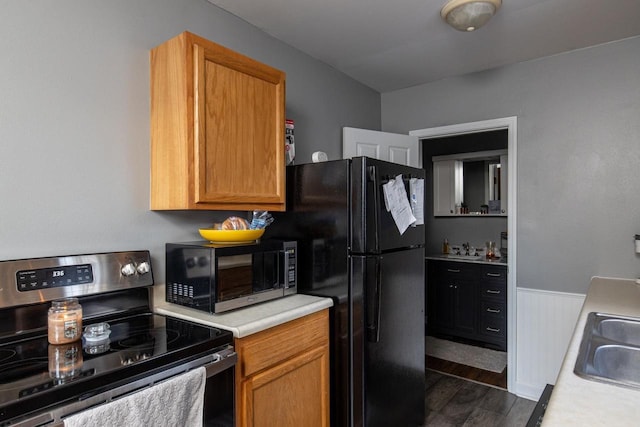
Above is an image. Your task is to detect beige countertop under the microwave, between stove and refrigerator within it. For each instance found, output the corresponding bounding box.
[153,285,333,338]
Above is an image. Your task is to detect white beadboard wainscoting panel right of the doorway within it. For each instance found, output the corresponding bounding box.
[509,288,586,400]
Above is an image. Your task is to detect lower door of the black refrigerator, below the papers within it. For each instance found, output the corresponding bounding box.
[352,248,425,427]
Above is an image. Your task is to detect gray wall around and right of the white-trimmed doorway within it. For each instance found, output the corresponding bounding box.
[382,37,640,293]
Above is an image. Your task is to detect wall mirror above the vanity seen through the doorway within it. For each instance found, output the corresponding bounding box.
[432,150,507,216]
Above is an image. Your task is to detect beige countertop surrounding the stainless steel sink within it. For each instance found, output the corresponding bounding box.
[542,277,640,427]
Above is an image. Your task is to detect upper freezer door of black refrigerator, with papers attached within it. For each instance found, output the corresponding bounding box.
[351,157,427,254]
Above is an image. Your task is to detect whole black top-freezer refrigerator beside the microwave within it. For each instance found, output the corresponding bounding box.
[265,157,425,427]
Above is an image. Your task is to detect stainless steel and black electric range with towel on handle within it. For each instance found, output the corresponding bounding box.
[0,251,237,426]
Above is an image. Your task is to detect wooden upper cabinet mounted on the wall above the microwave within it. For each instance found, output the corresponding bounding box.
[151,32,285,211]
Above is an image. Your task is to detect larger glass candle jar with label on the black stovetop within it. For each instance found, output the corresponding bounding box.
[48,298,82,344]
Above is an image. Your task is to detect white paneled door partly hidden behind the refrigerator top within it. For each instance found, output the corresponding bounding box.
[342,127,422,168]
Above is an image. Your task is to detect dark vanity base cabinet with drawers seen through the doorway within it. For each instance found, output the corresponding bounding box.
[426,260,507,351]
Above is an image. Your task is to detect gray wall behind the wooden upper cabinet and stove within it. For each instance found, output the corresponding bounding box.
[0,0,380,282]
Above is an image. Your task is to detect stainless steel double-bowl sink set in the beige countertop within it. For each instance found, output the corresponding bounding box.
[573,313,640,389]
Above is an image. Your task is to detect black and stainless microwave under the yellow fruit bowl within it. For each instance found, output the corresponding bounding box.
[166,240,298,313]
